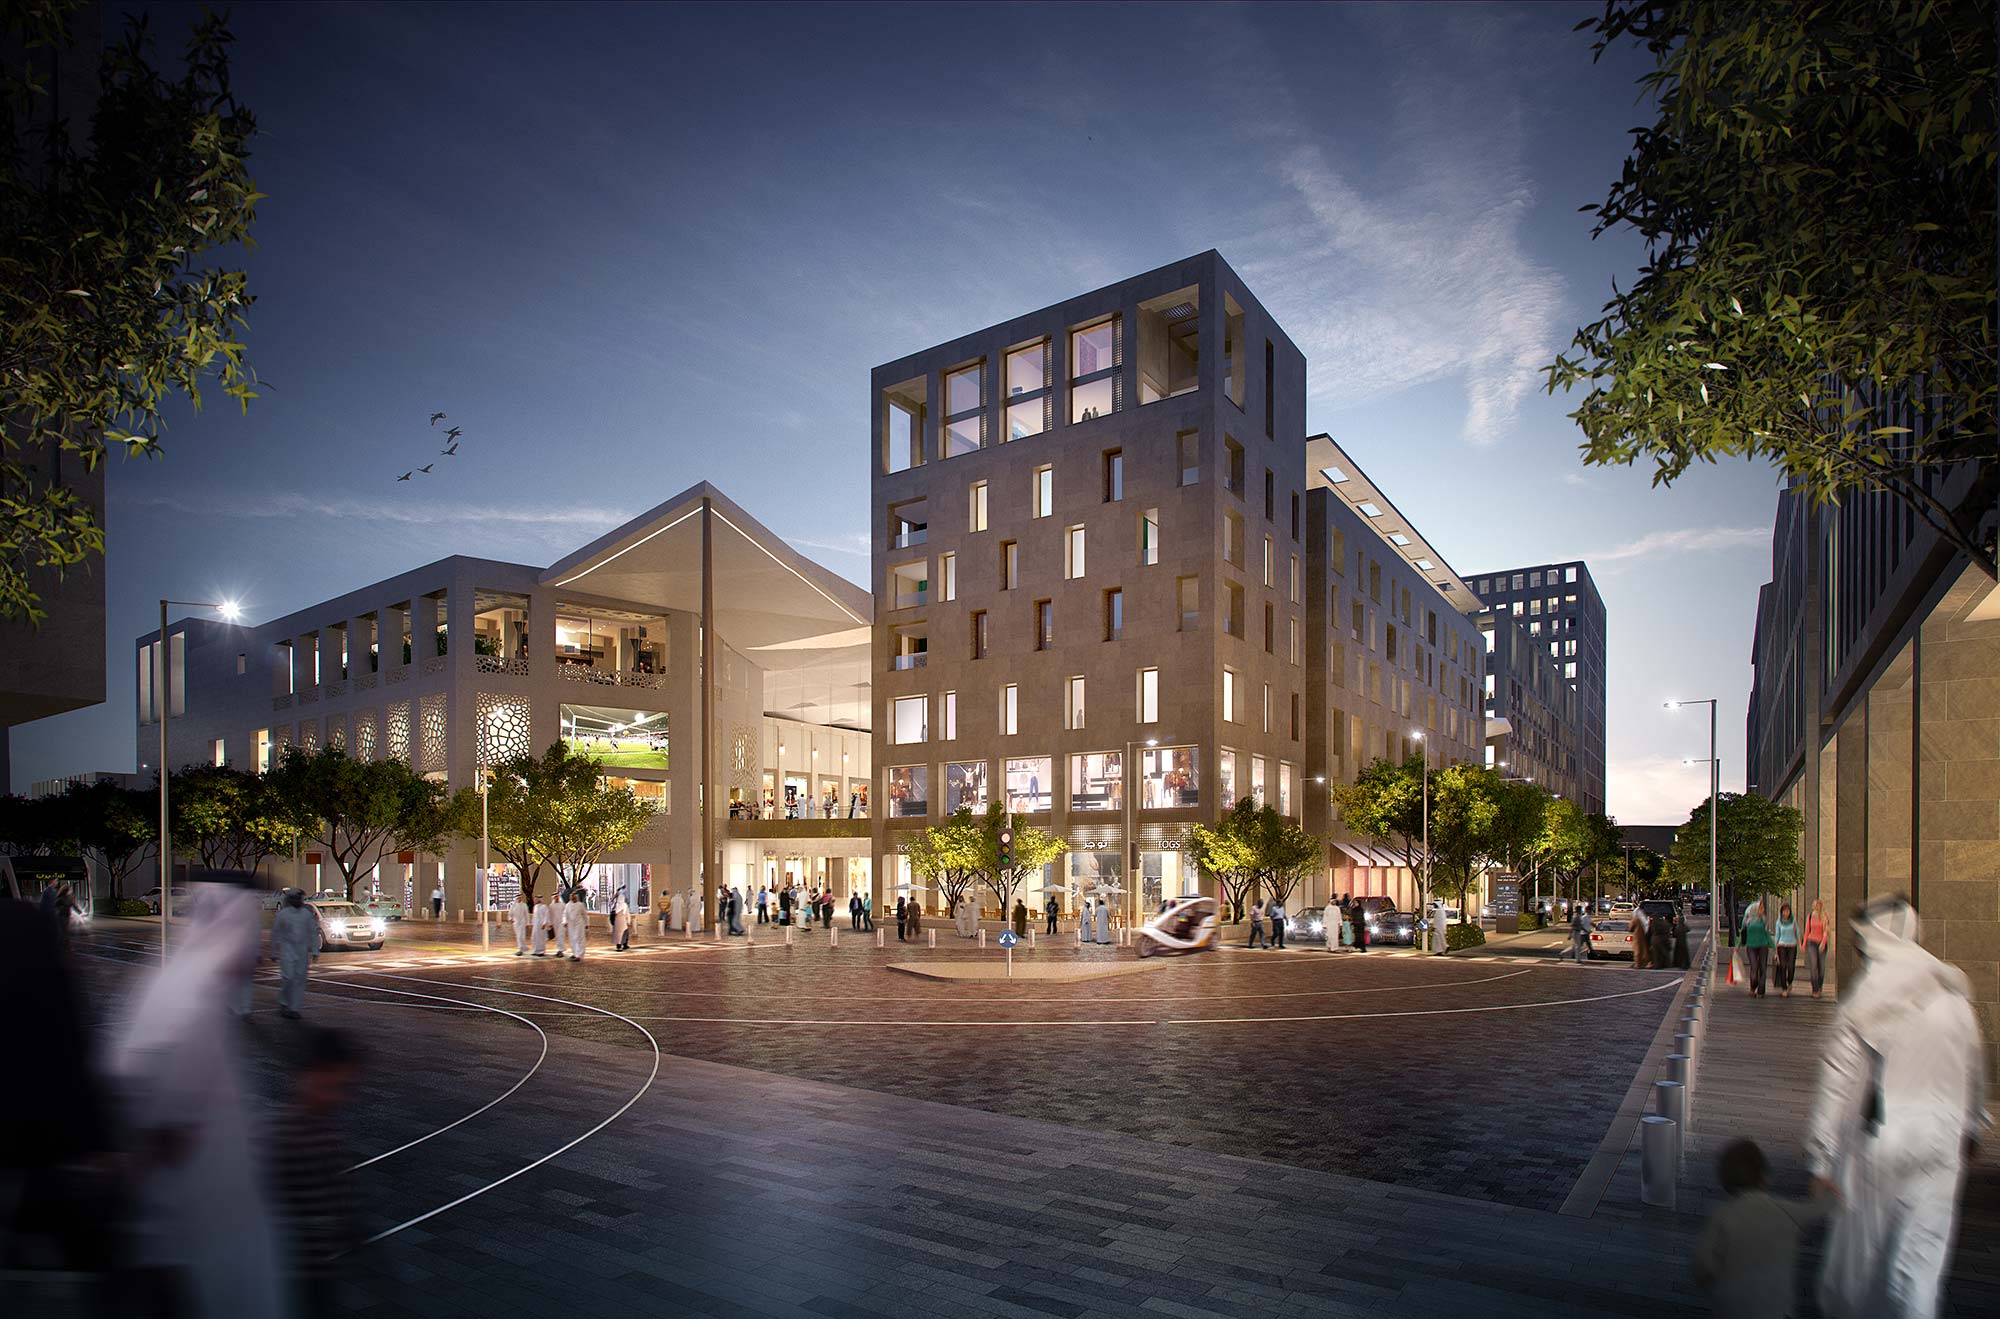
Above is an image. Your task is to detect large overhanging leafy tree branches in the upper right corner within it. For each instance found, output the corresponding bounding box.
[1548,0,2000,576]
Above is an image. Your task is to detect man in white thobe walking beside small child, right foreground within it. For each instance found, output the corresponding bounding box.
[1806,895,1986,1319]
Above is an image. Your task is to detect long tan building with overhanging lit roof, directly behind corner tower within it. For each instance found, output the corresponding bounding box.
[1302,436,1486,907]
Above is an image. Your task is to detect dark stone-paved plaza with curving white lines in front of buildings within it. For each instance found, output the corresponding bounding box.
[62,925,2000,1317]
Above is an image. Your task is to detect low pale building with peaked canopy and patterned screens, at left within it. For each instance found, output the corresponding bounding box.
[136,484,870,911]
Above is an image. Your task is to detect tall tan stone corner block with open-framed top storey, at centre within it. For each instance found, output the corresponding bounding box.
[870,252,1308,913]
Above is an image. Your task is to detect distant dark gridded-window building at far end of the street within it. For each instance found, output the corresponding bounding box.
[1468,560,1604,811]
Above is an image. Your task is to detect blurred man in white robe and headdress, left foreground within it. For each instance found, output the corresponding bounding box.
[112,883,282,1319]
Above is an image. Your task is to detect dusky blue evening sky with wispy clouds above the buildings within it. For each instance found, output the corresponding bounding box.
[14,4,1776,823]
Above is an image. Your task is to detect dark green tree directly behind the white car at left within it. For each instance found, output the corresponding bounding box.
[266,747,448,899]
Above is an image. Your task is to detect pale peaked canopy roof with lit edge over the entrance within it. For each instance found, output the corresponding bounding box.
[542,482,874,727]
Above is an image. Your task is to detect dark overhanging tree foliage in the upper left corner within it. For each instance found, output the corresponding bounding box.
[0,0,262,622]
